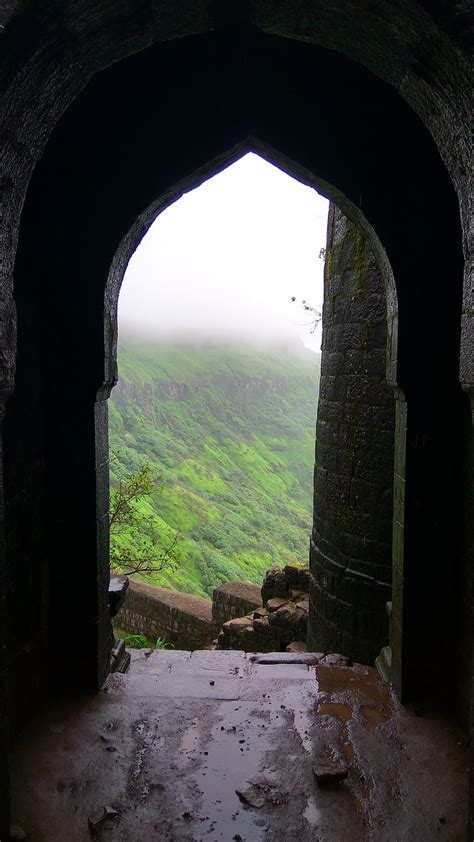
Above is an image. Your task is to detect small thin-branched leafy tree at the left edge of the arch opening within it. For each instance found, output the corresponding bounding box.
[109,453,180,576]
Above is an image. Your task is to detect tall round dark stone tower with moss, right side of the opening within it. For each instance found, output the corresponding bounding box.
[308,205,395,663]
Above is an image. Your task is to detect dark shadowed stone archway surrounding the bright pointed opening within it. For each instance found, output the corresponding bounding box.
[1,9,474,832]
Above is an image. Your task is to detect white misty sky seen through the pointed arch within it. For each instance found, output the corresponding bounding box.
[119,153,328,350]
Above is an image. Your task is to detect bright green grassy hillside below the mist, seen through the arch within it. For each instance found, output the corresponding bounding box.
[109,341,319,596]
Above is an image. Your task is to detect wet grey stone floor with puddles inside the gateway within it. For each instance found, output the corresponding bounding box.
[12,650,467,842]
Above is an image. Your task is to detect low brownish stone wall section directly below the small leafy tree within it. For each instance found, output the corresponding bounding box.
[114,580,212,649]
